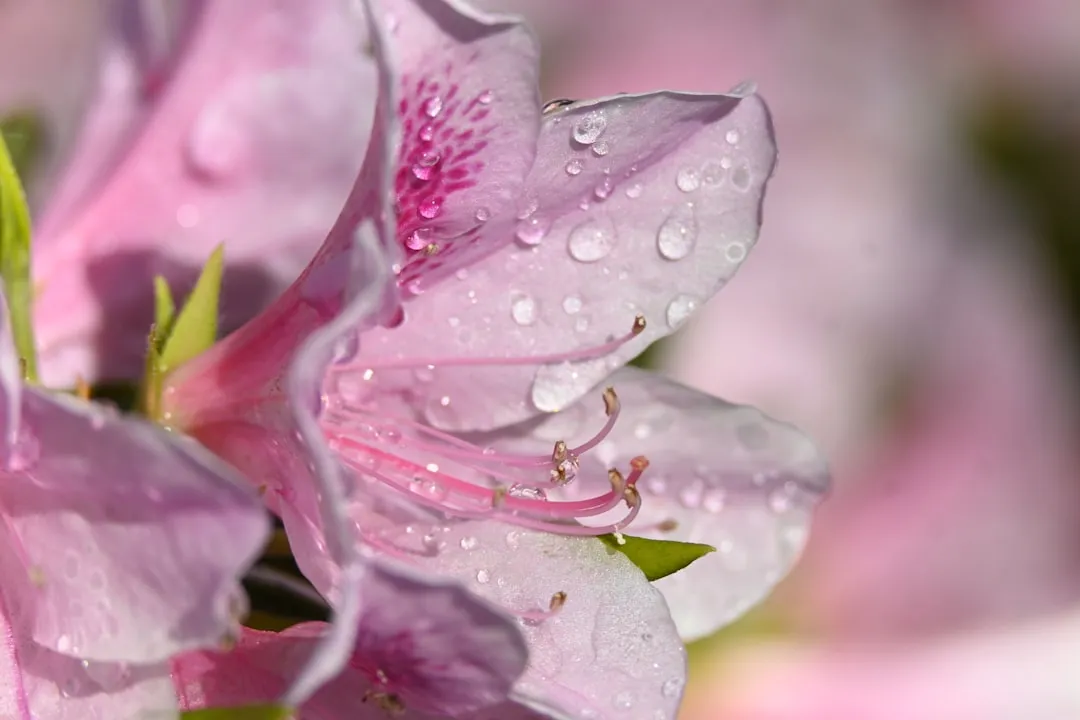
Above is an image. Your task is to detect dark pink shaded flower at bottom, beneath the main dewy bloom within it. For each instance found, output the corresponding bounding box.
[173,566,526,720]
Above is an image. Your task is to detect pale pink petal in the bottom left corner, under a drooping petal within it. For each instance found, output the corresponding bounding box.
[0,598,176,720]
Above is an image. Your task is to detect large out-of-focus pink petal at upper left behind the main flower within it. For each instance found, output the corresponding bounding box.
[35,0,375,383]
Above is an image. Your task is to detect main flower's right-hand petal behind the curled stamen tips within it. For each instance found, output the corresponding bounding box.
[480,367,828,641]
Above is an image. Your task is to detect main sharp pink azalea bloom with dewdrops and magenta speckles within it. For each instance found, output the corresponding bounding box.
[163,0,827,718]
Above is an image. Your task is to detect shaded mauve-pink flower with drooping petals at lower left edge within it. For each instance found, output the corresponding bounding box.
[0,284,268,720]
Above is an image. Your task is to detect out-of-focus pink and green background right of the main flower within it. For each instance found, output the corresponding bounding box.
[6,0,1080,720]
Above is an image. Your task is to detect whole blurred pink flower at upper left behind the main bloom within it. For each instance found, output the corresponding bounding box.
[0,0,375,384]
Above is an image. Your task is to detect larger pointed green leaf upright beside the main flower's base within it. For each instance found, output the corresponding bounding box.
[156,245,225,376]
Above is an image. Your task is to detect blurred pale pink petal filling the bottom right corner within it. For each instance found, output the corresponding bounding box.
[685,611,1080,720]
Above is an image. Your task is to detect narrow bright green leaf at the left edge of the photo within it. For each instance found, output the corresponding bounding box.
[0,131,38,382]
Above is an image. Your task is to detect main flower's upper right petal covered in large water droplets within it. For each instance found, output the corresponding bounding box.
[357,88,775,431]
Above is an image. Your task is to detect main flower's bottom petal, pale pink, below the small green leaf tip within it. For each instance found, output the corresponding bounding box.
[388,521,686,719]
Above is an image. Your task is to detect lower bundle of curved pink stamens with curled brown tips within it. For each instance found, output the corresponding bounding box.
[321,388,649,535]
